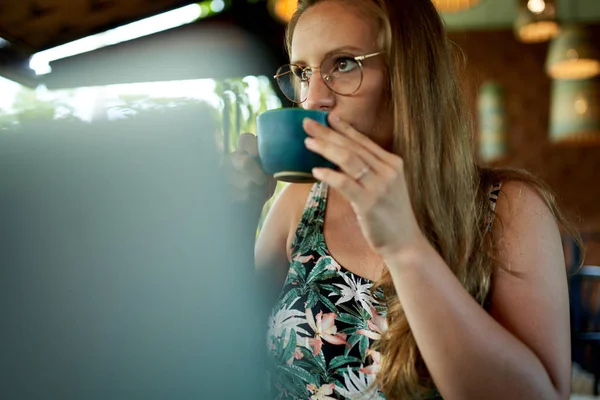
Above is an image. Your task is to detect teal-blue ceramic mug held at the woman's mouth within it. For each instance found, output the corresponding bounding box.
[256,108,336,183]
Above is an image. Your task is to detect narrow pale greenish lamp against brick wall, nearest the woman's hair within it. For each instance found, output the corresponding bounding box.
[477,81,508,162]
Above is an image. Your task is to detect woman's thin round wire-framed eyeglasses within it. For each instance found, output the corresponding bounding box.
[274,52,383,104]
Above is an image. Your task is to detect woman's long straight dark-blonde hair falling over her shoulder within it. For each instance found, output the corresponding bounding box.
[286,0,577,399]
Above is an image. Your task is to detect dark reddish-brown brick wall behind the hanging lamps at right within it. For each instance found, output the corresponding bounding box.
[450,25,600,264]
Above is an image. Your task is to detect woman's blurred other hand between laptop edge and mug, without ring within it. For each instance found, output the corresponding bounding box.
[226,133,276,213]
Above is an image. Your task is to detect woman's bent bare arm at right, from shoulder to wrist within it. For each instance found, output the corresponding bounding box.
[388,182,571,400]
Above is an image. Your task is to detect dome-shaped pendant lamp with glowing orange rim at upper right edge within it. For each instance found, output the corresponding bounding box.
[546,26,600,79]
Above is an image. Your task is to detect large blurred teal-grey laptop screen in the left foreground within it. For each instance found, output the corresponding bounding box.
[0,110,266,400]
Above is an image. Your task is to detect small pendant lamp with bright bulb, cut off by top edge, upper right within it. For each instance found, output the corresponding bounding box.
[515,0,560,43]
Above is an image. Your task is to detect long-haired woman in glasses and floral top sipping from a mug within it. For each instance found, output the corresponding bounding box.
[234,0,570,400]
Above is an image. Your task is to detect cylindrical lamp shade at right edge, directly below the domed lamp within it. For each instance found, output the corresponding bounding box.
[550,78,600,144]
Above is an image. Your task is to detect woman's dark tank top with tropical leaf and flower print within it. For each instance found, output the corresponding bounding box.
[267,183,499,400]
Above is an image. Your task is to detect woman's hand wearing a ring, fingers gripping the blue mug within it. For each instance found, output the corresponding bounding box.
[304,114,425,259]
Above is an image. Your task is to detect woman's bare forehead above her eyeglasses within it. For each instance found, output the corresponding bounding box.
[290,1,378,64]
